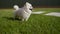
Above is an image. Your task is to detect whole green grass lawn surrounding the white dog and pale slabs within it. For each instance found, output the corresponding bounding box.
[0,8,60,34]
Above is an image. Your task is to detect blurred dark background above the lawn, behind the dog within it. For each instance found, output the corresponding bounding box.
[0,0,60,8]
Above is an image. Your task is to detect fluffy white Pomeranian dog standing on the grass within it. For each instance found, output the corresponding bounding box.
[14,2,33,21]
